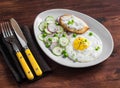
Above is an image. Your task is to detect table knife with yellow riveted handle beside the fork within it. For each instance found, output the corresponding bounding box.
[10,18,42,76]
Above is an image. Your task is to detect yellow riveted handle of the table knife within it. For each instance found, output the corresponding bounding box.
[25,48,42,76]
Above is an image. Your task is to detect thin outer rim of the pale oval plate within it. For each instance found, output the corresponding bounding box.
[33,9,114,68]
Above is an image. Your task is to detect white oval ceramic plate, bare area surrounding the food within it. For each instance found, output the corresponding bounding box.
[34,9,114,68]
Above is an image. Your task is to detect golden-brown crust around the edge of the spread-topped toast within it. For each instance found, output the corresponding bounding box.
[59,14,89,34]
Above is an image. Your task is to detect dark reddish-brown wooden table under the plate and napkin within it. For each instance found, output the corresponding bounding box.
[0,0,120,88]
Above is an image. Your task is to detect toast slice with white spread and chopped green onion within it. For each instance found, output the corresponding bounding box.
[59,14,89,34]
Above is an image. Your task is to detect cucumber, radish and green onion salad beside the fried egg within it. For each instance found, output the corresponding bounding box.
[38,16,70,58]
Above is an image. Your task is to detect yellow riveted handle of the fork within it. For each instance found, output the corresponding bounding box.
[16,52,34,80]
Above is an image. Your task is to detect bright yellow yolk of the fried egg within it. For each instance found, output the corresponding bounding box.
[73,37,90,50]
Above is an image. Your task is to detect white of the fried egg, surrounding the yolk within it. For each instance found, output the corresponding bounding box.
[66,31,103,62]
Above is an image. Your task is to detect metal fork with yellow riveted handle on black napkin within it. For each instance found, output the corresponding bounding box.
[0,22,34,80]
